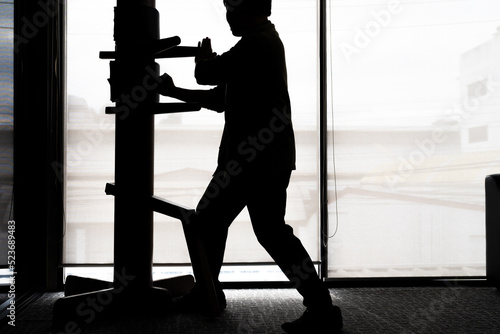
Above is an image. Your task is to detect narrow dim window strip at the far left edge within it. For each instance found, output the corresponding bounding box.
[0,1,14,284]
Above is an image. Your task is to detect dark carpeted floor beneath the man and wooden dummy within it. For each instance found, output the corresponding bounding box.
[0,286,500,334]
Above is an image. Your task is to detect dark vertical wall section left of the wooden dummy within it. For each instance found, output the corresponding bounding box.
[14,0,65,296]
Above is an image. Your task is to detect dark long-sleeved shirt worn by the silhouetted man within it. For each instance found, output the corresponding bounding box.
[195,21,295,170]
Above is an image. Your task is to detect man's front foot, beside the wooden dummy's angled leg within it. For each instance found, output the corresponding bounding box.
[173,285,227,314]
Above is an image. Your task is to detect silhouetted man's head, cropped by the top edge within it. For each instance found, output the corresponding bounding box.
[224,0,271,36]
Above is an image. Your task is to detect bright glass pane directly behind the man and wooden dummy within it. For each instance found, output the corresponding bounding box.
[64,0,319,279]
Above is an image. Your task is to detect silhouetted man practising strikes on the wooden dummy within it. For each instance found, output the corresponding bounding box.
[160,0,342,333]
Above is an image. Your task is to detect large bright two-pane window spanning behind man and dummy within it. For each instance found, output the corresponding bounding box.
[64,0,500,280]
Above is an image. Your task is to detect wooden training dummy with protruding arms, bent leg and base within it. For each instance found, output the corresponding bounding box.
[53,0,219,332]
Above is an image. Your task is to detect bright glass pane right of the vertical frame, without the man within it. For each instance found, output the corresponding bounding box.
[328,0,500,277]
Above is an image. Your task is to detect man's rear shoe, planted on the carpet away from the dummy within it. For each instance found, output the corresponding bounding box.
[281,306,343,334]
